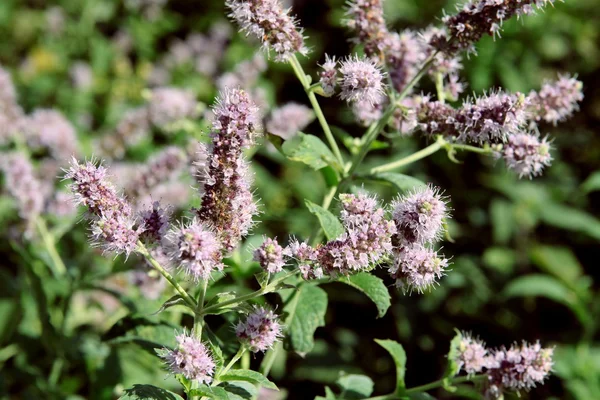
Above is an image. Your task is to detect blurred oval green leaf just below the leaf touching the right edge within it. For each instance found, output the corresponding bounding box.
[529,246,583,284]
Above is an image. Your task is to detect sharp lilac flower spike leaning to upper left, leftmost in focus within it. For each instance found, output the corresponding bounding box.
[65,159,143,255]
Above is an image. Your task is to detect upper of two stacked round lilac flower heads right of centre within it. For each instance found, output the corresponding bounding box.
[392,185,449,246]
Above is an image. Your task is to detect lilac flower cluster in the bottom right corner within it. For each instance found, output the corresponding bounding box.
[454,333,553,399]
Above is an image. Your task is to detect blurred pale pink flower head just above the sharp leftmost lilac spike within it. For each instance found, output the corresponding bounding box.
[23,109,79,160]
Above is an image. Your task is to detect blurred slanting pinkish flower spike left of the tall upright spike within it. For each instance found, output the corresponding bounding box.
[125,146,187,201]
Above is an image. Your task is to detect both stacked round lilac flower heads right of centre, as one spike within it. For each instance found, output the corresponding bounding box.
[388,186,449,292]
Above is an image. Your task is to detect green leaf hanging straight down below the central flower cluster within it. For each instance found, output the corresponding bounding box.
[283,284,327,354]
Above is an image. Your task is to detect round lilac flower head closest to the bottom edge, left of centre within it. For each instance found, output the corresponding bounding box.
[163,332,215,384]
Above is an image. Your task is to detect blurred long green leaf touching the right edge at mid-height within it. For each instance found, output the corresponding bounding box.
[540,203,600,240]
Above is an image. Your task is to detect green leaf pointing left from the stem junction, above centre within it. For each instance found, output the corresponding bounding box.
[281,132,340,170]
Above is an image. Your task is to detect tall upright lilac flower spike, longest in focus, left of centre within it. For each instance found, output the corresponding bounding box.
[197,89,261,252]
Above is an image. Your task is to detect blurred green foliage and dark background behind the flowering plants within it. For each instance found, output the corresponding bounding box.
[0,0,600,400]
